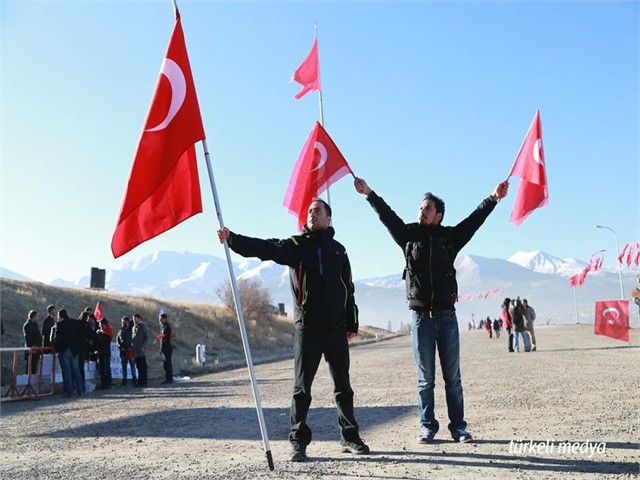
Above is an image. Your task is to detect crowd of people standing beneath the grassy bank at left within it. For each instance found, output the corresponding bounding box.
[16,305,174,397]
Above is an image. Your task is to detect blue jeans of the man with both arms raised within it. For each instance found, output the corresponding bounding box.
[411,311,467,438]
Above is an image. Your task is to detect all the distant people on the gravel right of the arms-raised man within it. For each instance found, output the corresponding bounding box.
[468,297,537,352]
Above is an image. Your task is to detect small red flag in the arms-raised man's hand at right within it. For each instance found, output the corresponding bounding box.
[509,110,549,226]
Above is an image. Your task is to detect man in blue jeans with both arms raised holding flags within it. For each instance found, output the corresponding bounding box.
[354,178,509,443]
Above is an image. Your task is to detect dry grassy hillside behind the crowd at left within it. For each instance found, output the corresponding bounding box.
[0,278,388,379]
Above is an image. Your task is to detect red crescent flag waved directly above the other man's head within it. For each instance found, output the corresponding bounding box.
[284,122,353,230]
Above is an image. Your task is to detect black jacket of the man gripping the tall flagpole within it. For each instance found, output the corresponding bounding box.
[229,226,358,333]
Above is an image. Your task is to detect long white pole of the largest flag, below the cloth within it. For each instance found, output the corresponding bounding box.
[202,140,274,470]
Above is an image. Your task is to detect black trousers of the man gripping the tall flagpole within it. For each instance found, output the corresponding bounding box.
[289,328,360,446]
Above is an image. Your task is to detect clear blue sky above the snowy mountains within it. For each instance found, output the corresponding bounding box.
[0,0,640,281]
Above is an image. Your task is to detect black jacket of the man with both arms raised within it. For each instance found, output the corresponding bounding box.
[367,191,497,310]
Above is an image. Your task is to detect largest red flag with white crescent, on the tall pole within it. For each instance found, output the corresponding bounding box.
[111,12,205,258]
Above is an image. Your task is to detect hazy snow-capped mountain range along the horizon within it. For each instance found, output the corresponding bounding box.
[0,251,638,330]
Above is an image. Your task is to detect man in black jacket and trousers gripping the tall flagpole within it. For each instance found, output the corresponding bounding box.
[218,199,369,462]
